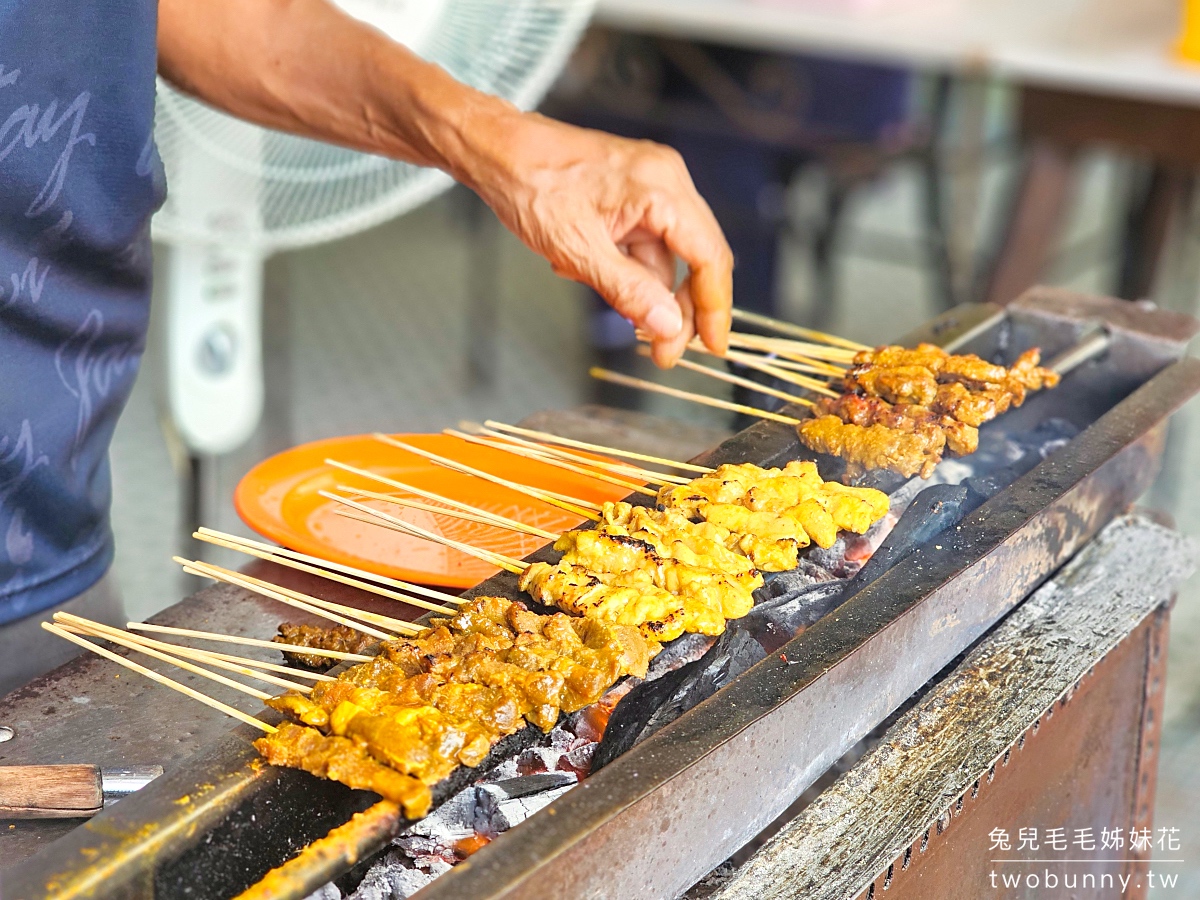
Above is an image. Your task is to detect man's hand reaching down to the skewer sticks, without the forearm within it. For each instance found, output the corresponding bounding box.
[456,110,733,366]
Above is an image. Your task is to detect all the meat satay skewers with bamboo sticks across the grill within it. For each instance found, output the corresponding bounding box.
[37,312,1057,840]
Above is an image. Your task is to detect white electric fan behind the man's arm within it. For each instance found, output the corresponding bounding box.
[154,0,594,454]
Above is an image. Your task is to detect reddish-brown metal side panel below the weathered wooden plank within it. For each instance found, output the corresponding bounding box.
[849,616,1166,900]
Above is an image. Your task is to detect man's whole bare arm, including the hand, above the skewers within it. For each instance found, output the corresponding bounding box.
[158,0,733,365]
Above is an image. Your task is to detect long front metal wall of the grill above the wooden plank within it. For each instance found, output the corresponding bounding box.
[421,360,1200,900]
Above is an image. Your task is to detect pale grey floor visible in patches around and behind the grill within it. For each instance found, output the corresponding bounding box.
[113,141,1200,896]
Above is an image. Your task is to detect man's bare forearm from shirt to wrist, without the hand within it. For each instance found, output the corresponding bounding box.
[158,0,515,182]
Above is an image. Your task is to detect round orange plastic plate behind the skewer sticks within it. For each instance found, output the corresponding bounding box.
[234,434,643,588]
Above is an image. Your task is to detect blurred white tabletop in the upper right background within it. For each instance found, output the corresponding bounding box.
[596,0,1200,106]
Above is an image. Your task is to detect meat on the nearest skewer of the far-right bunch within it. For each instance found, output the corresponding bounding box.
[797,415,946,478]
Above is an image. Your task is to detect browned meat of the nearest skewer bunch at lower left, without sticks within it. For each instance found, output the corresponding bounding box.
[256,598,660,817]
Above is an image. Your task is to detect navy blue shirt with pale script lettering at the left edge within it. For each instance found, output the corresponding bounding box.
[0,0,164,624]
